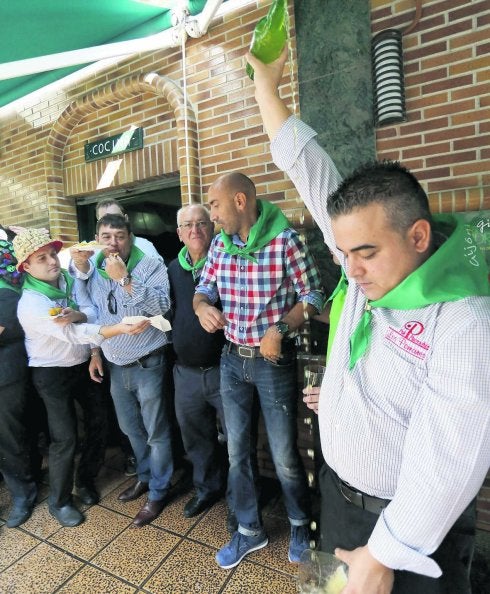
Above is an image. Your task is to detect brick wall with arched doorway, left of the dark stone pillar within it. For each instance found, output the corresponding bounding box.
[0,0,302,241]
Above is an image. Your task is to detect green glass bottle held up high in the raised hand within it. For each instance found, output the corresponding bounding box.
[246,0,288,80]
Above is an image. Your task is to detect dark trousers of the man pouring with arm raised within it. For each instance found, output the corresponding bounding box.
[320,465,476,594]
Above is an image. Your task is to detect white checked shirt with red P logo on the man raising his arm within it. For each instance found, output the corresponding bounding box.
[272,117,490,577]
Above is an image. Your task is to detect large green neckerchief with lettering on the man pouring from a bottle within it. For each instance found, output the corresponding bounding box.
[349,215,489,369]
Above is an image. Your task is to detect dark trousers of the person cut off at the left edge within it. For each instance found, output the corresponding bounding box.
[0,380,37,506]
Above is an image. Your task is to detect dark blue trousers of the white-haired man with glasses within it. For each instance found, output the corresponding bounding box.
[174,363,227,498]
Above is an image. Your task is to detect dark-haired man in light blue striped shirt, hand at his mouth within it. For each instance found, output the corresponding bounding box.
[77,214,173,527]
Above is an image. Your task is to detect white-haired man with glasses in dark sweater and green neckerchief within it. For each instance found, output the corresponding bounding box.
[168,204,232,518]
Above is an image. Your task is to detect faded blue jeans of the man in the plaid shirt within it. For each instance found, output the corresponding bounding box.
[221,346,310,535]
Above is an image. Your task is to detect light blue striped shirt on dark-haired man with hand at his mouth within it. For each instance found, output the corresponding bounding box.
[87,256,170,365]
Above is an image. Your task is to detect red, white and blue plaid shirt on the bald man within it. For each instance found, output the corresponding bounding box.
[196,229,323,346]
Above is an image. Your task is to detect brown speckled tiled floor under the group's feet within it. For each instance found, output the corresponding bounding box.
[0,450,297,594]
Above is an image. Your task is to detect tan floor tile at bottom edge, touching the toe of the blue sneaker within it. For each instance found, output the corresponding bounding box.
[144,540,229,594]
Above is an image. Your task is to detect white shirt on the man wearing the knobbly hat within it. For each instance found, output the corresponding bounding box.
[17,276,104,367]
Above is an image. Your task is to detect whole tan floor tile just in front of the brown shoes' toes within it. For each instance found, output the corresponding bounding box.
[92,525,180,586]
